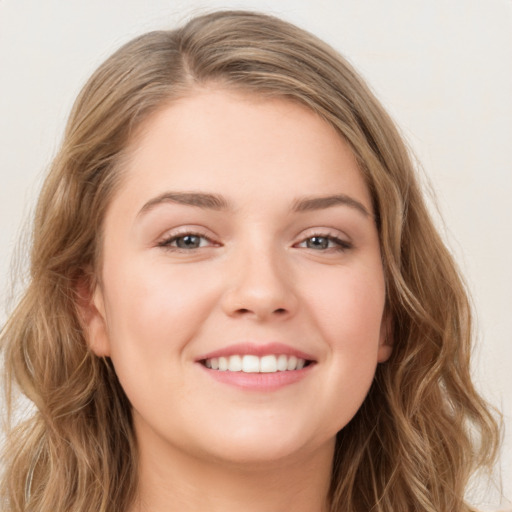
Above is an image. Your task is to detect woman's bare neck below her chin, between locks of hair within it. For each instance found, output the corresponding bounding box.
[129,428,334,512]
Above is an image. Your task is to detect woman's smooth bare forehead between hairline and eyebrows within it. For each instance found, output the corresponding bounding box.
[115,88,371,210]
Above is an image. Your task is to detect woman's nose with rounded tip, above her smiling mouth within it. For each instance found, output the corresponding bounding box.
[222,244,298,321]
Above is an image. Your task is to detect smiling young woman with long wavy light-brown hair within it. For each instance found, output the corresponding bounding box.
[2,12,497,512]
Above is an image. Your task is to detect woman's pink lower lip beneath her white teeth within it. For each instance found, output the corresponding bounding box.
[198,363,315,391]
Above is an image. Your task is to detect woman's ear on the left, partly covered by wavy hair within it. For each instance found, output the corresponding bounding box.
[75,276,110,357]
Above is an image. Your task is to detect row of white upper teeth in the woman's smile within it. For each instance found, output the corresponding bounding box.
[204,354,306,373]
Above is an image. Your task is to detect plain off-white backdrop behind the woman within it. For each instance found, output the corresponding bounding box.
[0,0,512,510]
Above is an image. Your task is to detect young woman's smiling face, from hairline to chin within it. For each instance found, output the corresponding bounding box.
[89,89,391,468]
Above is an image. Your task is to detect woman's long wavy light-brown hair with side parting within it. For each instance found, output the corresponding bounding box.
[1,11,498,512]
